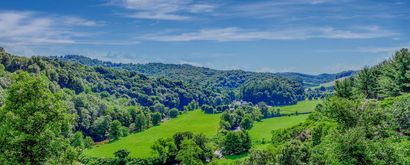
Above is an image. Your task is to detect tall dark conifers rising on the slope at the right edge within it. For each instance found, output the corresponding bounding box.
[336,48,410,99]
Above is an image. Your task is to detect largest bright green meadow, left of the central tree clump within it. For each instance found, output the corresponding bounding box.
[85,110,223,157]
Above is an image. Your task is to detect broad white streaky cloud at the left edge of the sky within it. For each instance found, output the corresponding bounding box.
[0,11,139,47]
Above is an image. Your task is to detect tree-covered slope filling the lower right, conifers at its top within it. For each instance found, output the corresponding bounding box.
[239,49,410,165]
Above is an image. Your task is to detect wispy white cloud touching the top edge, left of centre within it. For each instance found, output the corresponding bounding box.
[109,0,216,21]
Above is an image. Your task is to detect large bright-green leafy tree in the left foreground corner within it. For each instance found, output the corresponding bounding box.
[0,72,76,164]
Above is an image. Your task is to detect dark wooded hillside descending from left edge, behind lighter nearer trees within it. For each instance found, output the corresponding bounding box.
[0,53,225,109]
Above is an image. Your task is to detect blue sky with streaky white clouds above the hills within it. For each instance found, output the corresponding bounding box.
[0,0,410,74]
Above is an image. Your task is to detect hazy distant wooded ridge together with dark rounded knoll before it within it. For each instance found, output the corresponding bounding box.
[57,55,356,104]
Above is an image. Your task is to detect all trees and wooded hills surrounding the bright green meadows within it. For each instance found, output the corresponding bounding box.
[0,49,410,164]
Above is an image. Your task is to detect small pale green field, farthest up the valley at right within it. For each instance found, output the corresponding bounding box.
[278,100,322,114]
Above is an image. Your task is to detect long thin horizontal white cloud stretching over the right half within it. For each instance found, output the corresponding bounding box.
[139,26,397,42]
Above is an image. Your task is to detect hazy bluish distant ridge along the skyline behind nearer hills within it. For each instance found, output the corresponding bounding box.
[55,55,356,89]
